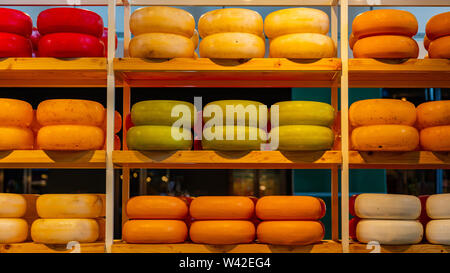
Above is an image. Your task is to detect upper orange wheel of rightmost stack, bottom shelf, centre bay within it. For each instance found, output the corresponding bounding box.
[256,196,326,220]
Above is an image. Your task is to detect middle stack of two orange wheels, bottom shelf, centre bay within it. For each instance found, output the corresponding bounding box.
[189,196,255,245]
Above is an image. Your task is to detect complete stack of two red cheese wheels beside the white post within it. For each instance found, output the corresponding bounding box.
[37,8,105,58]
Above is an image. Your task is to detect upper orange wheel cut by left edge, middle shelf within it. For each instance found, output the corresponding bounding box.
[0,98,33,127]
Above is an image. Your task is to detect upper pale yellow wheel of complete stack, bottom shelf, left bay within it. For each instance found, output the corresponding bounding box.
[36,194,103,218]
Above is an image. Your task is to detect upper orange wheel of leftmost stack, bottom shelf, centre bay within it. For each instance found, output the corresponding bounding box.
[127,195,188,219]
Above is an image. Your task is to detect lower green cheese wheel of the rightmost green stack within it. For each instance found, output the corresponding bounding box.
[270,125,334,151]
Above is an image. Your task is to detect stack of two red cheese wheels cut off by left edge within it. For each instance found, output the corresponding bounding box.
[0,8,33,58]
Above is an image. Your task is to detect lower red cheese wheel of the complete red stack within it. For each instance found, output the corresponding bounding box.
[38,32,105,58]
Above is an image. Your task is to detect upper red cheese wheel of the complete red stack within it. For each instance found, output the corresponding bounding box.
[37,8,103,38]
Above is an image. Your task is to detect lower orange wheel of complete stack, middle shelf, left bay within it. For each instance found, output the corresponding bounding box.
[36,125,104,151]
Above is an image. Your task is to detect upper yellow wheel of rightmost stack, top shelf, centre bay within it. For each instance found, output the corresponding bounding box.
[264,8,330,39]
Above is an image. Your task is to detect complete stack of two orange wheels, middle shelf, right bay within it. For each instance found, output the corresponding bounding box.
[349,99,419,151]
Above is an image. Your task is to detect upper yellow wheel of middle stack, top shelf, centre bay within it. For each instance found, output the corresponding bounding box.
[198,8,263,38]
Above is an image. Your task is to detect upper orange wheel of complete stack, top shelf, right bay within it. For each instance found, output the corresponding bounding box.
[352,9,418,39]
